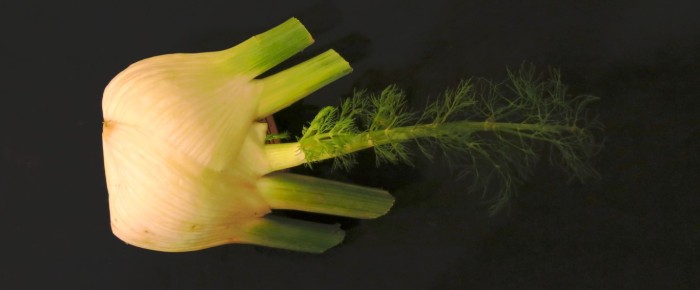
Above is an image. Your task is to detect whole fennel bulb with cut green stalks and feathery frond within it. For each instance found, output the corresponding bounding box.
[102,18,597,253]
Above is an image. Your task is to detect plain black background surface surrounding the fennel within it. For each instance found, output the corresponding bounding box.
[0,0,700,289]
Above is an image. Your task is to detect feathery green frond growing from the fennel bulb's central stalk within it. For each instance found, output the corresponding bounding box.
[299,66,601,212]
